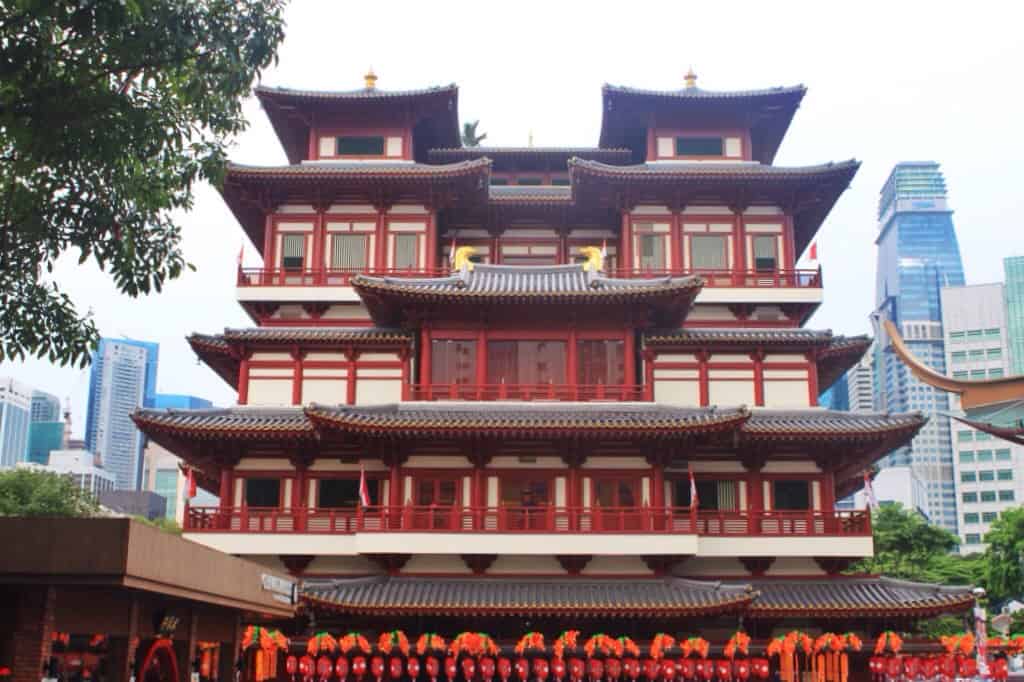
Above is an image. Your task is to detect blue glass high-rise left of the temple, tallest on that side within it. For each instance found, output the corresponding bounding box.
[85,339,160,489]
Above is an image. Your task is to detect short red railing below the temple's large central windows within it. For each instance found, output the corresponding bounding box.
[410,384,653,402]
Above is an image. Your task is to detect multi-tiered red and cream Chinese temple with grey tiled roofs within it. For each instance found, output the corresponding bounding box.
[134,72,973,682]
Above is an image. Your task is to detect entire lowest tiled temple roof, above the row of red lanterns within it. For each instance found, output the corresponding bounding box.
[301,576,974,619]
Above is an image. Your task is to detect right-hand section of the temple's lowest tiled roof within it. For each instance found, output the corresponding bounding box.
[748,577,974,617]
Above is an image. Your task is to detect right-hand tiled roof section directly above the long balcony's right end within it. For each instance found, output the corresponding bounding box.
[740,408,928,441]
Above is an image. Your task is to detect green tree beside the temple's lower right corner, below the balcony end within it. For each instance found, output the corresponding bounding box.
[850,504,984,585]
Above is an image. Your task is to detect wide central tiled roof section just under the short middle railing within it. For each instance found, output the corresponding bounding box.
[307,402,748,438]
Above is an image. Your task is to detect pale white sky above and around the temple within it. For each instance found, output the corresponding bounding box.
[0,0,1024,434]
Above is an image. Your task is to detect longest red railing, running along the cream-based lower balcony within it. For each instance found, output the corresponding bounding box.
[184,505,871,538]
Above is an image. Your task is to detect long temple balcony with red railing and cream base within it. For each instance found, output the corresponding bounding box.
[184,505,872,557]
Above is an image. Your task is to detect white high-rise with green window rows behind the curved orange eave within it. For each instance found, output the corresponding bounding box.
[942,284,1024,553]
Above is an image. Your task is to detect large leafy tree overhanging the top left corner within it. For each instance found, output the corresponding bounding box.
[0,0,284,365]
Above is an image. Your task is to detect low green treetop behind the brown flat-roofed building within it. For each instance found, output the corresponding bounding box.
[0,469,99,516]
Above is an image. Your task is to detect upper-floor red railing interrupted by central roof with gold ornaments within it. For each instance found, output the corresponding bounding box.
[238,267,821,289]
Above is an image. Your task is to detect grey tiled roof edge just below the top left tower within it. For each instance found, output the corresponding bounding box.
[227,159,490,179]
